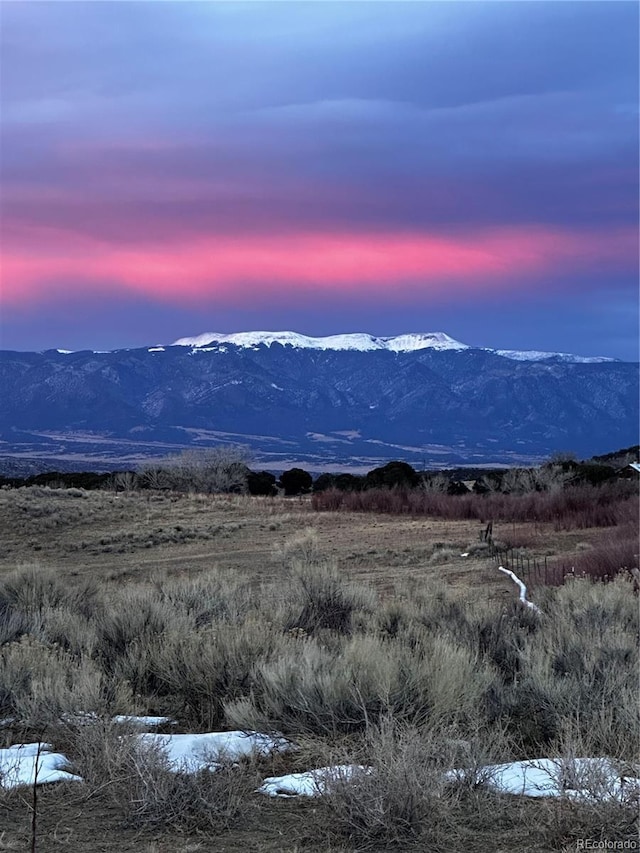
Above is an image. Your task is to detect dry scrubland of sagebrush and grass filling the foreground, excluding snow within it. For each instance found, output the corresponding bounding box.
[0,487,640,853]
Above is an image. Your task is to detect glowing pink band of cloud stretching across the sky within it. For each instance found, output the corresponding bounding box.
[0,227,637,305]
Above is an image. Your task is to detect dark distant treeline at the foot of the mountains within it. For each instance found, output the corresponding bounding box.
[0,445,640,496]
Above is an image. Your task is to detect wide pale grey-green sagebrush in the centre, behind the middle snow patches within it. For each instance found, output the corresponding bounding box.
[225,631,494,734]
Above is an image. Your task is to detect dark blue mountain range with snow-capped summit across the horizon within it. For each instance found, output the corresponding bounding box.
[0,332,639,470]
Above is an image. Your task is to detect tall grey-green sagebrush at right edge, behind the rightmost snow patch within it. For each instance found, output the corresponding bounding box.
[498,577,639,760]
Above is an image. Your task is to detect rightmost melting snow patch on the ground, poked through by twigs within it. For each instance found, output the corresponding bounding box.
[447,758,640,800]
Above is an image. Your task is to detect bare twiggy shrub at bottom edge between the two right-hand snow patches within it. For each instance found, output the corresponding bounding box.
[323,717,516,851]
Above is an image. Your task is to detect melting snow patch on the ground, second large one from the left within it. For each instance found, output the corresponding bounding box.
[137,732,294,773]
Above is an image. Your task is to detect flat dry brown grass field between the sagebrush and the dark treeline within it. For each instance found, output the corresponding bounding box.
[0,487,620,599]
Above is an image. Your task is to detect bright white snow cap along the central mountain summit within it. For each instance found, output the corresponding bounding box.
[173,332,469,352]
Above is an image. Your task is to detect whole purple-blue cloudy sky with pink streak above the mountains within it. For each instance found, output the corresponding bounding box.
[0,0,640,360]
